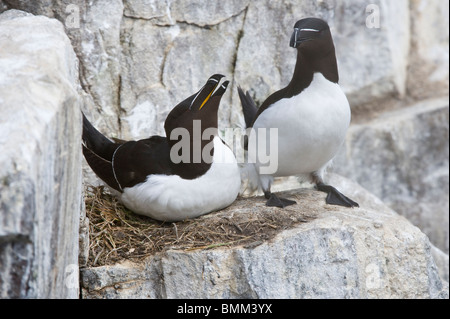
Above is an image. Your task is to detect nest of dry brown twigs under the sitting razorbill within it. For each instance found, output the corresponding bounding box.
[85,187,312,267]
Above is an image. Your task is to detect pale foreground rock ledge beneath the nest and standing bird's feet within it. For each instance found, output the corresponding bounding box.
[81,182,448,298]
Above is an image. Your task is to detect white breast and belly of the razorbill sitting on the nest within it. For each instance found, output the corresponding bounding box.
[120,137,241,221]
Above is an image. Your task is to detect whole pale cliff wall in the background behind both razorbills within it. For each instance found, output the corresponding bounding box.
[0,0,449,295]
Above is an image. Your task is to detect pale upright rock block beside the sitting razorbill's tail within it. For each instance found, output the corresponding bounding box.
[0,10,82,298]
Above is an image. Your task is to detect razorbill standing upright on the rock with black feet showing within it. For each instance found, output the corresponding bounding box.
[238,18,359,208]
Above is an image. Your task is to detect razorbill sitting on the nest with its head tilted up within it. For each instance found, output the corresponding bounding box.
[83,74,241,221]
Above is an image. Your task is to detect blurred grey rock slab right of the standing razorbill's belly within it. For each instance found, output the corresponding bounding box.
[333,97,449,253]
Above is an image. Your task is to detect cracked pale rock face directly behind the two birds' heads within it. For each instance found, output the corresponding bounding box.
[5,0,410,138]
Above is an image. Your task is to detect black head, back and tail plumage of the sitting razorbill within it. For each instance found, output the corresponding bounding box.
[82,75,228,191]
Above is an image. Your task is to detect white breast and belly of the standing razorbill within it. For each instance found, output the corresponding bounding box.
[249,73,350,177]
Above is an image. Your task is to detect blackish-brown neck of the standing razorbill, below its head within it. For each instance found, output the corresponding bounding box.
[286,47,339,96]
